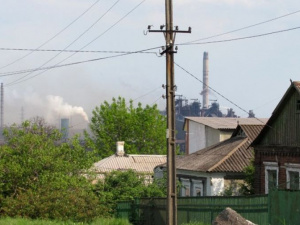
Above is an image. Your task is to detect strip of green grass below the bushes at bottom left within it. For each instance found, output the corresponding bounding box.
[0,218,131,225]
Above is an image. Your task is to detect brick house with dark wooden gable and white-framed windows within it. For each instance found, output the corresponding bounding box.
[252,81,300,194]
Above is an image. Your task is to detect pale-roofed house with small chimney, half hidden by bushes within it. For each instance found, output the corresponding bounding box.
[93,141,167,181]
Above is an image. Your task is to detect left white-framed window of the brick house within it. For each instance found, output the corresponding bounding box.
[263,162,278,194]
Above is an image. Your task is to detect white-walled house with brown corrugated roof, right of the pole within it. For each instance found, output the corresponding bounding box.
[154,125,263,196]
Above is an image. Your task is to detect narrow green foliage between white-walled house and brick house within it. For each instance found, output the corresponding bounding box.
[240,160,255,195]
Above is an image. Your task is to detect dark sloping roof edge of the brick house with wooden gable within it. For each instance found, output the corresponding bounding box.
[251,81,300,146]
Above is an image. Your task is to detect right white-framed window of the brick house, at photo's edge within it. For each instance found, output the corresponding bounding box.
[285,163,300,190]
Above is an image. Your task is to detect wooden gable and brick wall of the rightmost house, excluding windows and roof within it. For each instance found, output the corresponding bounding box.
[254,90,300,194]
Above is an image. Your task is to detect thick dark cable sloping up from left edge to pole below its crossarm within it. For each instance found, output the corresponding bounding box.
[0,47,161,78]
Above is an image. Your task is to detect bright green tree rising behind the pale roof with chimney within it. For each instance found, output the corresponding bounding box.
[90,97,166,157]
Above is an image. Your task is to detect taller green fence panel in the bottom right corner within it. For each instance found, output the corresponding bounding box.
[269,190,300,225]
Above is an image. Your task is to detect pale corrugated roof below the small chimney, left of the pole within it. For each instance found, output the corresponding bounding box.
[94,155,167,173]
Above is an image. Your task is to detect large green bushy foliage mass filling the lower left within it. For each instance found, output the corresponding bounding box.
[0,121,103,221]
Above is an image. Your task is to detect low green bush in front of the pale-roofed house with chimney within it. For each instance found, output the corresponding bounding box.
[95,170,166,214]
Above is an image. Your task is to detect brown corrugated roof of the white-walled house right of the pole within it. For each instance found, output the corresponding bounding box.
[163,125,263,173]
